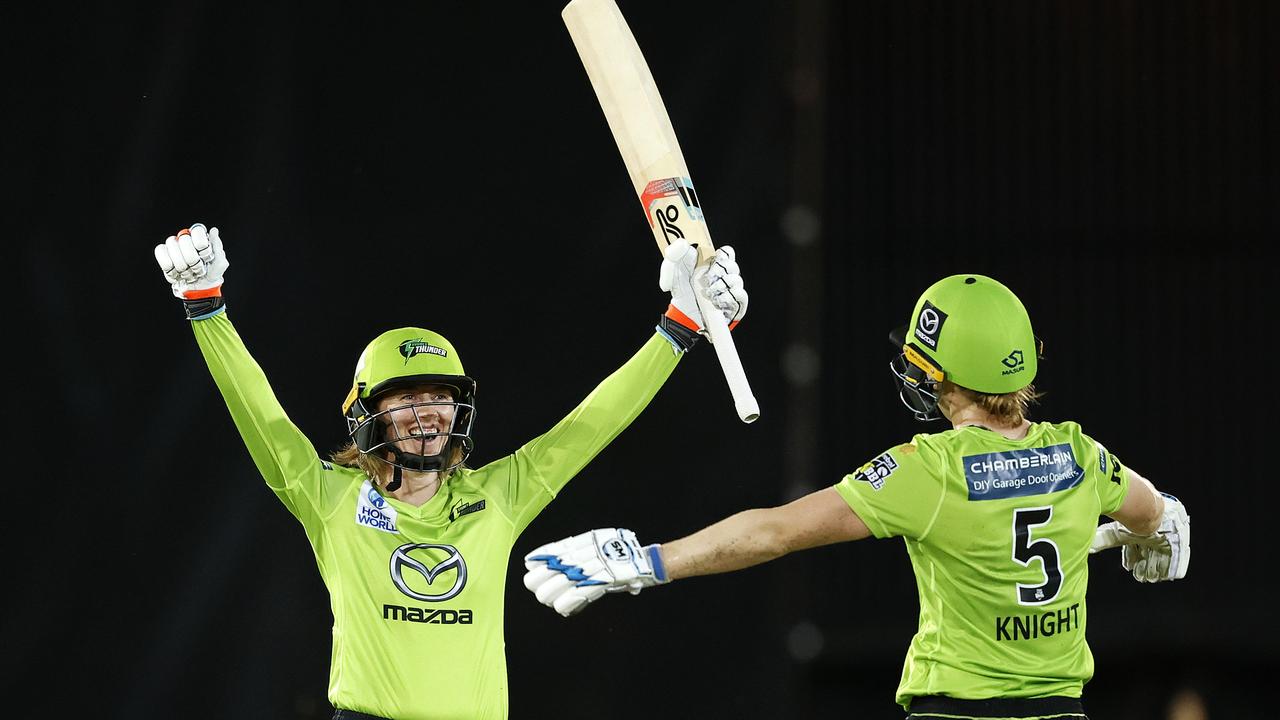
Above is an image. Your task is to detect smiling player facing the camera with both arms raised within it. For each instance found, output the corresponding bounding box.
[155,223,748,720]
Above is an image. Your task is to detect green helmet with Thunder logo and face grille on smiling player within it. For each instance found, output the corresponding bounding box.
[342,328,476,479]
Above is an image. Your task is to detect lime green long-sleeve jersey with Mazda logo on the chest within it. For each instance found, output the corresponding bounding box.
[192,313,680,720]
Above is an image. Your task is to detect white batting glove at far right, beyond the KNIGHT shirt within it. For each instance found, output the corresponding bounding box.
[1089,492,1192,583]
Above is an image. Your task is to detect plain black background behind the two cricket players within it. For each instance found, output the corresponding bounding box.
[0,0,1280,720]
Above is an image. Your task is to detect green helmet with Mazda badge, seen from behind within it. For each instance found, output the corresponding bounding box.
[890,274,1041,420]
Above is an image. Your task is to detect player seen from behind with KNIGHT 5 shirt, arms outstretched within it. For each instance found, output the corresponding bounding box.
[525,274,1190,720]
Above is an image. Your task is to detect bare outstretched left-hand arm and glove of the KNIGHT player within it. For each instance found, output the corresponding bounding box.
[525,488,872,618]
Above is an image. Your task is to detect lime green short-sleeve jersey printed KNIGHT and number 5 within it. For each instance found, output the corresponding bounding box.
[836,423,1129,707]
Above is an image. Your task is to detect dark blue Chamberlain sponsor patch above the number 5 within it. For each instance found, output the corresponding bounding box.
[963,443,1084,500]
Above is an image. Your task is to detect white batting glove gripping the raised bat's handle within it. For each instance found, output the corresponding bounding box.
[658,240,748,334]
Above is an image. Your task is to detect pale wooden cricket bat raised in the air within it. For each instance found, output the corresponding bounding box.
[561,0,760,423]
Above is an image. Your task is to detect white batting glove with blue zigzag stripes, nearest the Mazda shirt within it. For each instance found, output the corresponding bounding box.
[525,528,667,618]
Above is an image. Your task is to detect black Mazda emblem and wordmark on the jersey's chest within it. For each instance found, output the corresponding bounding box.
[383,543,472,625]
